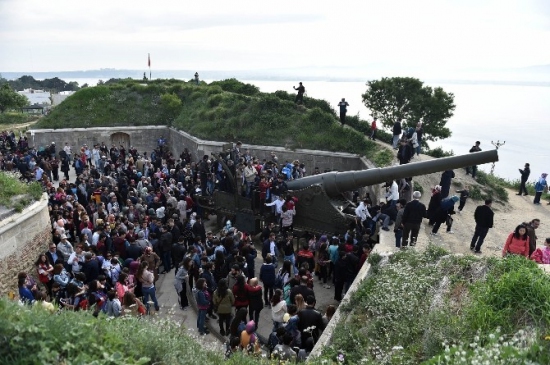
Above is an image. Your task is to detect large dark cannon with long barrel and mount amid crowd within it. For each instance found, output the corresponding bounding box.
[203,150,498,233]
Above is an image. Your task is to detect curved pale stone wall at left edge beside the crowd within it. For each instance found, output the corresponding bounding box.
[0,194,51,296]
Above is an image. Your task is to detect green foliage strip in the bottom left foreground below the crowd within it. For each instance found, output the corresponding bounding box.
[0,299,266,365]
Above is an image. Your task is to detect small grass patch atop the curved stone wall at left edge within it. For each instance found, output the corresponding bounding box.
[0,171,42,212]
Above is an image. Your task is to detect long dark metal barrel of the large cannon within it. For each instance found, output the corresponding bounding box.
[287,150,498,197]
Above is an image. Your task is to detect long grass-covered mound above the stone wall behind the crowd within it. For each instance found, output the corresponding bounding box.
[34,79,390,165]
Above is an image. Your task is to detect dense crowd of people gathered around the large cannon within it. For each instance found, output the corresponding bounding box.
[0,124,550,360]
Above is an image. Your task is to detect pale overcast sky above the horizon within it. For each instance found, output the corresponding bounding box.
[0,0,550,74]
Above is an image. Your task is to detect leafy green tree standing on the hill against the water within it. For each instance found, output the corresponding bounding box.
[362,77,455,141]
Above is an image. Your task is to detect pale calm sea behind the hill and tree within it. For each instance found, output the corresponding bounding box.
[66,79,550,181]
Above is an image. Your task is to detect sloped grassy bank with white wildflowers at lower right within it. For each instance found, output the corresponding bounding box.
[316,246,550,364]
